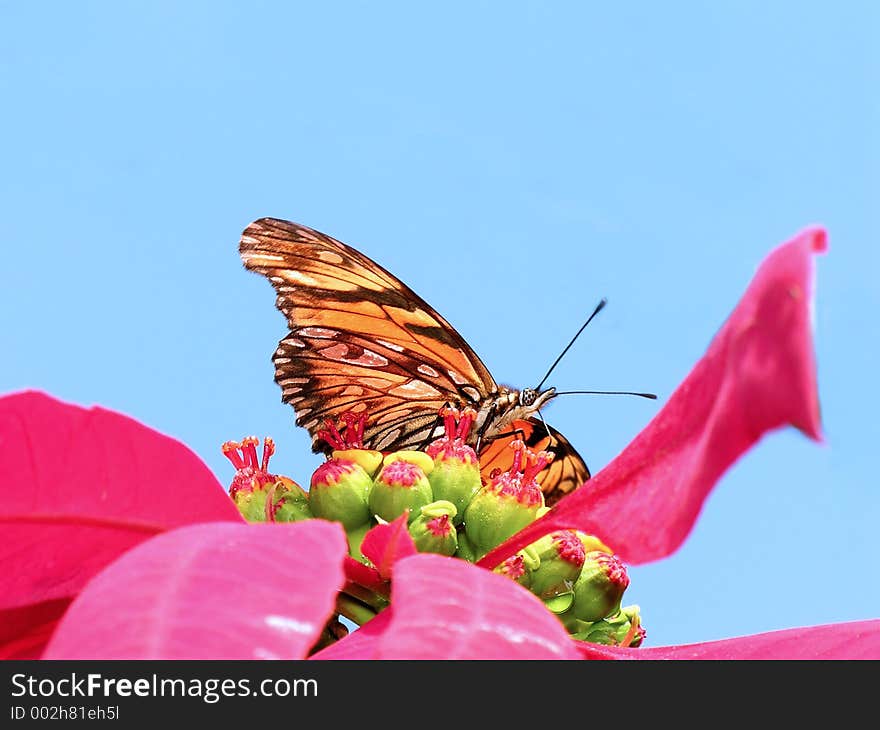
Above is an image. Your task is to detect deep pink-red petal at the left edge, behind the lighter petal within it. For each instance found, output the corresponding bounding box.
[0,392,241,610]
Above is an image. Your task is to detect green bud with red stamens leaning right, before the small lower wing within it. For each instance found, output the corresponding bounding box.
[464,441,551,555]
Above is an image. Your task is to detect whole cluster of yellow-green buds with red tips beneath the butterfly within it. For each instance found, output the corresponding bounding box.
[225,409,645,646]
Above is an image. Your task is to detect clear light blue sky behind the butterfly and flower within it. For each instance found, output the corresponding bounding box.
[0,2,880,645]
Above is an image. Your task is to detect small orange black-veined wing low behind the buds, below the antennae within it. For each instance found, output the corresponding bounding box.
[480,418,590,506]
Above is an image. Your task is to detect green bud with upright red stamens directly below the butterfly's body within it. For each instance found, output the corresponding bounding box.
[425,408,483,525]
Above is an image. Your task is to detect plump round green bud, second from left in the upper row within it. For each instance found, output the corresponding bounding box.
[309,459,373,530]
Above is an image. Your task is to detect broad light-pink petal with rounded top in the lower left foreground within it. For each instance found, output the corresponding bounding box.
[45,520,348,659]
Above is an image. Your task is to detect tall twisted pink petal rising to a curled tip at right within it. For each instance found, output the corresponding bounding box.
[480,228,826,567]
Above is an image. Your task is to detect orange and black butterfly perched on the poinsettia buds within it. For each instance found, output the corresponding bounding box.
[239,218,590,504]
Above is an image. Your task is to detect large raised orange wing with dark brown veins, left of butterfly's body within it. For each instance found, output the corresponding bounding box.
[239,213,497,450]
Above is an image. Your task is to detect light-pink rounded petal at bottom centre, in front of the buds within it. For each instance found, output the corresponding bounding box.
[372,554,578,659]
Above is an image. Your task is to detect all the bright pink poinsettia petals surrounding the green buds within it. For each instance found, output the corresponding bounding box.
[0,229,880,659]
